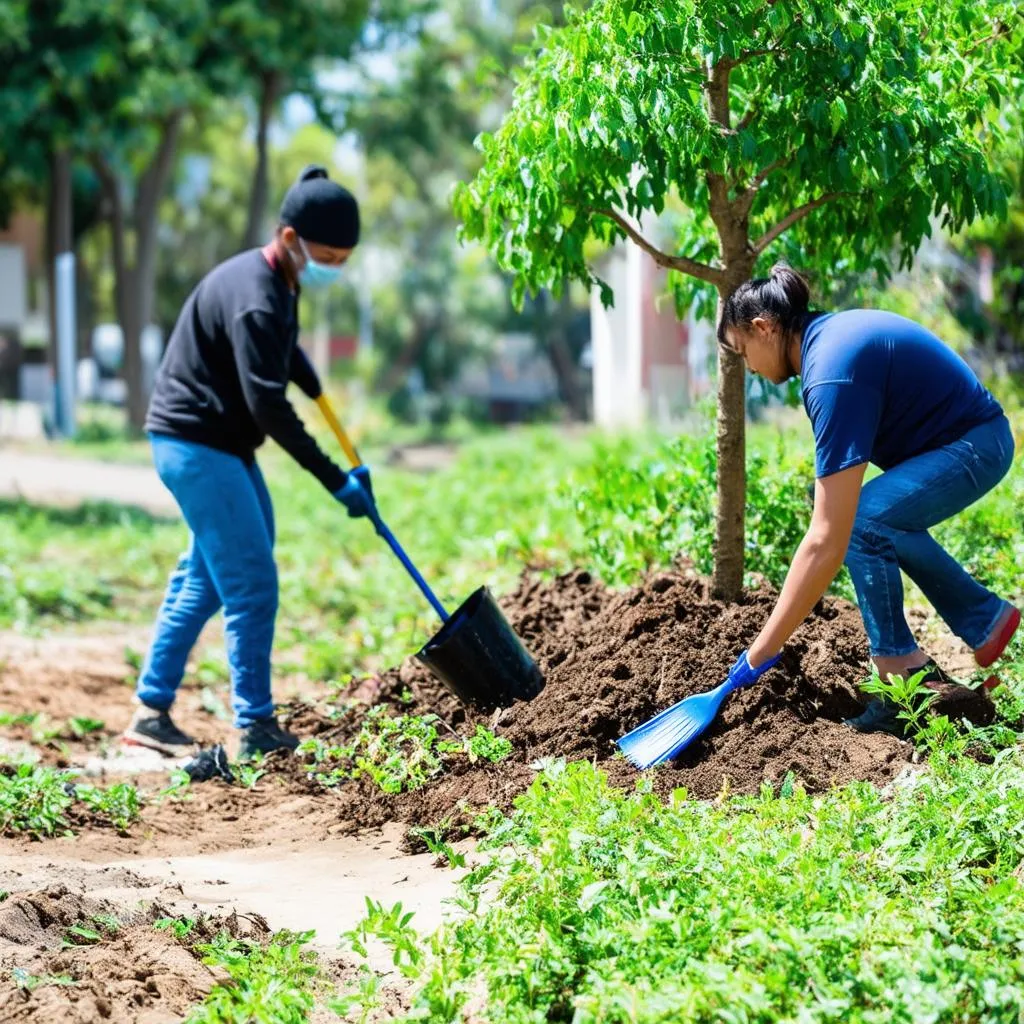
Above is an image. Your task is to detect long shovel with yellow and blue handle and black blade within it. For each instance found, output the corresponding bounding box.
[316,393,544,712]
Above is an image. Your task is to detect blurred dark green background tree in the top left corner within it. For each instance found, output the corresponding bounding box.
[0,0,243,428]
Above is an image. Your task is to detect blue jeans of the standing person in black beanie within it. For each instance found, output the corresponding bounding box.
[136,434,278,729]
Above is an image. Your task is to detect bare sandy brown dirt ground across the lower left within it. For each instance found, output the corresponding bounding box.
[0,629,468,1024]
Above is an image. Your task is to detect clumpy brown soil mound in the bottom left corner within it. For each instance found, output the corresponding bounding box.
[0,884,268,1024]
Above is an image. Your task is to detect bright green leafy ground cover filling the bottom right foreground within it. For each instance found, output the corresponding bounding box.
[339,746,1024,1024]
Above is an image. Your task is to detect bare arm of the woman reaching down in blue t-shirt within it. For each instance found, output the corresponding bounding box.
[748,463,867,668]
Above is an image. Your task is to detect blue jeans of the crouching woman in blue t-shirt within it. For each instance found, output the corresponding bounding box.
[846,416,1014,657]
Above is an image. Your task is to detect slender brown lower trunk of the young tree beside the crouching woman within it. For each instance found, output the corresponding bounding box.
[712,289,746,601]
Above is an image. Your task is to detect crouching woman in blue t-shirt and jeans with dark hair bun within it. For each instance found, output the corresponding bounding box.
[719,264,1021,734]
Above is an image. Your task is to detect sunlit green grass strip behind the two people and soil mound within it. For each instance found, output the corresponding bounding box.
[6,411,1024,684]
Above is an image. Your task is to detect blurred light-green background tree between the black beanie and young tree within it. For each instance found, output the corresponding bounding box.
[344,0,580,413]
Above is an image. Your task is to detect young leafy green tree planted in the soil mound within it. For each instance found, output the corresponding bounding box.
[455,0,1022,599]
